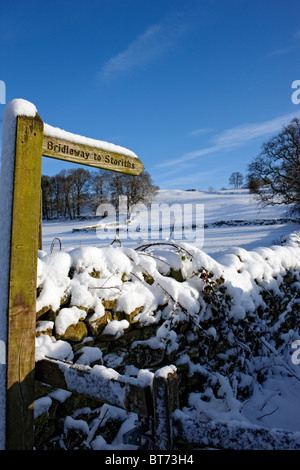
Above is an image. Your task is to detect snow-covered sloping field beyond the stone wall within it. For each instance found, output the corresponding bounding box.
[43,189,299,261]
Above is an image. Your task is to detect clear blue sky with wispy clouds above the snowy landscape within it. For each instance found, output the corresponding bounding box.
[0,0,300,190]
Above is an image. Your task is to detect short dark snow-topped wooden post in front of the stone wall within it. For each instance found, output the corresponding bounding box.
[153,366,179,450]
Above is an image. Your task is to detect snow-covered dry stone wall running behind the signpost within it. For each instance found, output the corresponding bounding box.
[36,234,300,448]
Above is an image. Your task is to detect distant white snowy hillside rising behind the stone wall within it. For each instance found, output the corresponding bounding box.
[43,189,300,256]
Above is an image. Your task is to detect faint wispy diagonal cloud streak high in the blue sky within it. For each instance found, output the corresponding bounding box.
[99,15,187,79]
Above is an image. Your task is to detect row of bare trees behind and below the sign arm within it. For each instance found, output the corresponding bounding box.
[41,168,159,219]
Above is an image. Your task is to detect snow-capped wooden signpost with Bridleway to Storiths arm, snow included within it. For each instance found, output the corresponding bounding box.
[0,99,144,450]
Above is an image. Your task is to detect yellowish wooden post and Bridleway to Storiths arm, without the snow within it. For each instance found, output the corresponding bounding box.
[0,101,144,450]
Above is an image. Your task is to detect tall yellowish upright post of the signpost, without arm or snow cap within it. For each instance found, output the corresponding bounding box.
[6,115,43,450]
